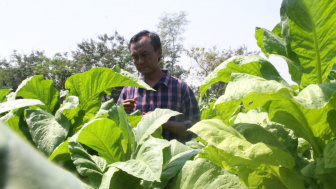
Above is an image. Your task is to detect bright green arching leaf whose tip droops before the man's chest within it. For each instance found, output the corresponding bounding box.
[65,67,152,118]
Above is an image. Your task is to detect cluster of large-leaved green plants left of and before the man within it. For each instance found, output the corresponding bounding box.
[0,66,198,188]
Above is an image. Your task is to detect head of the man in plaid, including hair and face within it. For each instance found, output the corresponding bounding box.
[129,31,162,77]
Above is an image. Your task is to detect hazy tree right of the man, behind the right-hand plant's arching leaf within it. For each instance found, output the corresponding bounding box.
[185,45,260,103]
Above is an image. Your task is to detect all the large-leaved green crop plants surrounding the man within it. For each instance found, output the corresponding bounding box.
[0,0,336,189]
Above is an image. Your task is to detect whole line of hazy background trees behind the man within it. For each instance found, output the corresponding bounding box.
[0,12,259,103]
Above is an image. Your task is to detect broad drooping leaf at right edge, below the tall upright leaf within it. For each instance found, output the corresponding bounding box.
[243,83,336,156]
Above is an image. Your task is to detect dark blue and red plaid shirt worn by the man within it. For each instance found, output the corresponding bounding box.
[118,70,200,142]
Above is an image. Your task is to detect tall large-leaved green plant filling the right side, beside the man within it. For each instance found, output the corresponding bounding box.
[194,0,336,188]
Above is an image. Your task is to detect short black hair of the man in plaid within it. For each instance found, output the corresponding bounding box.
[128,30,162,52]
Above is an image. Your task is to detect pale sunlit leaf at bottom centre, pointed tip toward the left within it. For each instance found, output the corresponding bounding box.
[110,136,169,181]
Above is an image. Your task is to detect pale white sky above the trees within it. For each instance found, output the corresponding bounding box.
[0,0,291,83]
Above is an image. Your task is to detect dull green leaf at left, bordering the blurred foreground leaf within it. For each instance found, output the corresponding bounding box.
[26,109,69,156]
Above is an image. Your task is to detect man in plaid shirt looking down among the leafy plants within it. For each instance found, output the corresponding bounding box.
[118,30,200,142]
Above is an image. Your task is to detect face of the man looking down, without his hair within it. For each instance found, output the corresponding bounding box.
[130,36,162,76]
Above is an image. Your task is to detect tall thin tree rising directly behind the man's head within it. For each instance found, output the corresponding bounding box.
[157,11,189,78]
